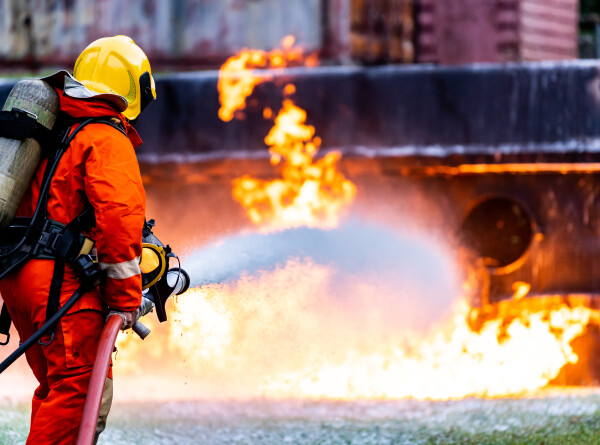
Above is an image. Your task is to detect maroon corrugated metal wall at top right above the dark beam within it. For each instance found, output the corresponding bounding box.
[350,0,578,65]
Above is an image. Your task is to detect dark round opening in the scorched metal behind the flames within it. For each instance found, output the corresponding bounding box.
[460,197,534,269]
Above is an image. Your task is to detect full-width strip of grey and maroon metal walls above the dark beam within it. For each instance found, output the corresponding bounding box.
[0,0,600,69]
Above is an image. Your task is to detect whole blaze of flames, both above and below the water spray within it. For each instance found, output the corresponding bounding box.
[116,38,598,400]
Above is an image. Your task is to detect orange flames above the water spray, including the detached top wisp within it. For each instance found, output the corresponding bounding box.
[219,36,356,231]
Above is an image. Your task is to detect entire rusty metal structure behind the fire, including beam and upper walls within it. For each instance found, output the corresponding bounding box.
[0,0,600,310]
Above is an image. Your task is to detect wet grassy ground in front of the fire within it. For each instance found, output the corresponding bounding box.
[0,389,600,445]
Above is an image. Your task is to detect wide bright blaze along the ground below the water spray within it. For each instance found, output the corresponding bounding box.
[116,260,598,400]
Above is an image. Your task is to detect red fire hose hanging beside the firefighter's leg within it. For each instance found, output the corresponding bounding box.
[77,314,123,445]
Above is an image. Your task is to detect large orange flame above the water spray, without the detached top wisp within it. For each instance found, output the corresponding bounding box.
[233,99,356,231]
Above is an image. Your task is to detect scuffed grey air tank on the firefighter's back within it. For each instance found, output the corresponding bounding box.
[0,79,59,229]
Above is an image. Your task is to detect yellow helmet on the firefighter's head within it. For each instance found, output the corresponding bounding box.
[73,36,156,120]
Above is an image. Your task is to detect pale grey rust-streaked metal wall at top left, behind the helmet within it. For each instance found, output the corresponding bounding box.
[0,0,338,66]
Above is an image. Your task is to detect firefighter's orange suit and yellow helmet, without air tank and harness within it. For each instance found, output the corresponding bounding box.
[0,36,156,445]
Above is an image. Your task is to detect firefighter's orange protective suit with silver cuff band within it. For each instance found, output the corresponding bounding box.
[0,90,145,445]
